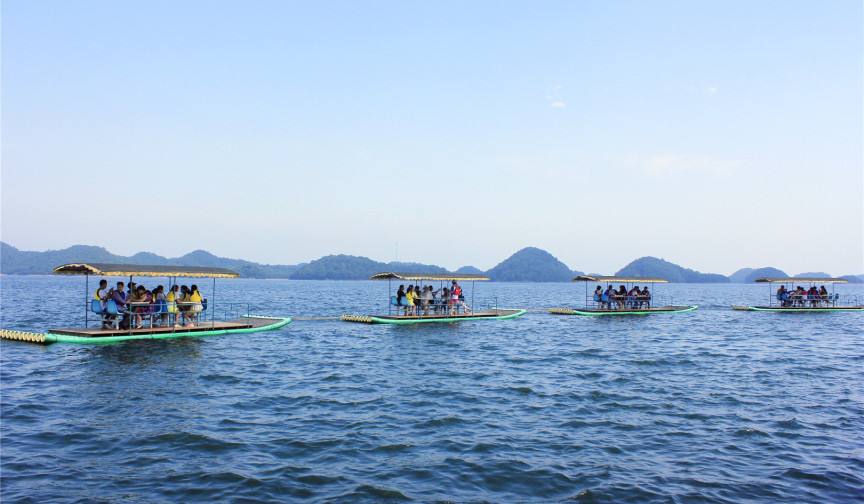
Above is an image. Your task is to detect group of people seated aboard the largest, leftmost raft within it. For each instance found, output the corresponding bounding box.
[93,279,204,330]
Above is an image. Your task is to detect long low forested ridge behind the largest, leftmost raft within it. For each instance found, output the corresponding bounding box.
[0,242,298,278]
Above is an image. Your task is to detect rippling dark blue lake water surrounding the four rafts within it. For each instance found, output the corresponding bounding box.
[0,276,864,504]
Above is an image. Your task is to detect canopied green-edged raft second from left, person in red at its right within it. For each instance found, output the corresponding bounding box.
[341,272,526,324]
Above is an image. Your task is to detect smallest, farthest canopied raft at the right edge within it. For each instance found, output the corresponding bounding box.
[732,277,864,313]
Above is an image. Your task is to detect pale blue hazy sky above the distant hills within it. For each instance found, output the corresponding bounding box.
[0,0,864,275]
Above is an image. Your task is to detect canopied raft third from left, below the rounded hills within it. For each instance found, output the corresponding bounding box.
[549,275,697,315]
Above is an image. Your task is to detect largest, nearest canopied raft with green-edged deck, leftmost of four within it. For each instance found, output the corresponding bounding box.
[0,263,291,343]
